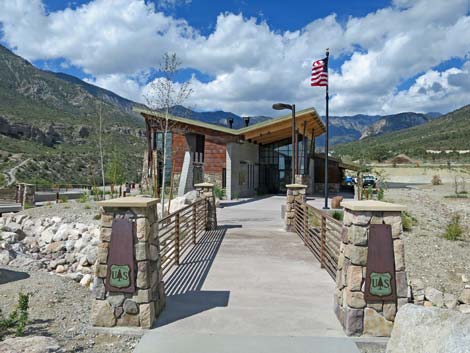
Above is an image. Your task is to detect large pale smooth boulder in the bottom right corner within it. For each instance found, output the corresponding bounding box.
[387,304,470,353]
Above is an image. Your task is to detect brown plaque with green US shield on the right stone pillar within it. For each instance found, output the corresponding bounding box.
[364,224,397,302]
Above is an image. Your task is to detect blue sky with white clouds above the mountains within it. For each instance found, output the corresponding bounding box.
[0,0,470,116]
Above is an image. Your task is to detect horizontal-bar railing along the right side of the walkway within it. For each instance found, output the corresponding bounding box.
[294,201,345,279]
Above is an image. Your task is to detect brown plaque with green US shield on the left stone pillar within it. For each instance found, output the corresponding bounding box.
[106,218,135,293]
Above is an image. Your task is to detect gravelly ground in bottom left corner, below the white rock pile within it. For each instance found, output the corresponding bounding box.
[0,267,138,353]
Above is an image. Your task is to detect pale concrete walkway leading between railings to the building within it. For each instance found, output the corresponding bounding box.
[135,196,358,353]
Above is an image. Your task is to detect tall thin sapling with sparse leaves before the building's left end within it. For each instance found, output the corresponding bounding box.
[144,53,192,217]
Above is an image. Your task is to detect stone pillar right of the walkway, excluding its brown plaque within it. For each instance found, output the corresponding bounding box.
[335,200,408,337]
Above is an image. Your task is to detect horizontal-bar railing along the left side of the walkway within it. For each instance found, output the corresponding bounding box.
[158,199,208,276]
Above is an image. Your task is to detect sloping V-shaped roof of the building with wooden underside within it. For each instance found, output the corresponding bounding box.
[134,108,326,144]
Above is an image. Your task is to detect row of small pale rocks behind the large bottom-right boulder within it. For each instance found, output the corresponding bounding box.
[411,276,470,313]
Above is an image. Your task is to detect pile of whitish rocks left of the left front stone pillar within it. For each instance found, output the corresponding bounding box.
[0,210,100,287]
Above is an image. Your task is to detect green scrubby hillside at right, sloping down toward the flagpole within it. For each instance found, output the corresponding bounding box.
[334,105,470,160]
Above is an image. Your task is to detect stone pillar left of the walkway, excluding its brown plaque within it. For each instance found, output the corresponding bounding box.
[91,197,165,328]
